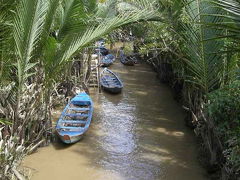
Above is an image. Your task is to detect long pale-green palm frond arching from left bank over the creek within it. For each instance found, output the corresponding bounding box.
[59,0,156,62]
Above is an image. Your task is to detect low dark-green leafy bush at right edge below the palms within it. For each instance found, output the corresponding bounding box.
[205,81,240,172]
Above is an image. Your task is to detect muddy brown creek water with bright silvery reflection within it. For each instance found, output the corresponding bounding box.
[24,62,207,180]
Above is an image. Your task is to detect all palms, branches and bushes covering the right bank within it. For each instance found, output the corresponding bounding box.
[120,0,240,179]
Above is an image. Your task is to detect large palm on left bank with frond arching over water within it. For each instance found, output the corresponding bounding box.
[0,0,159,143]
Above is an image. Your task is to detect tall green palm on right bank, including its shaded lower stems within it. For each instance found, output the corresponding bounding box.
[142,0,240,176]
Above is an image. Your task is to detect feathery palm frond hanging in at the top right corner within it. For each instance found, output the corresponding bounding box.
[200,0,240,83]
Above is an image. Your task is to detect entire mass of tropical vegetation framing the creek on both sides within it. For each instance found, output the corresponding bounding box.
[0,0,240,179]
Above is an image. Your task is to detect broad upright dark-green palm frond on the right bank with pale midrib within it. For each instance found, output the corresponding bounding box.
[182,1,227,93]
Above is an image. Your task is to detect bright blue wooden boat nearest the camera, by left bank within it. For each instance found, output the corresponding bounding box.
[56,92,93,144]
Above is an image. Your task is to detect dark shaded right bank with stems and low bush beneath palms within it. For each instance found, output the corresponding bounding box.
[144,54,239,180]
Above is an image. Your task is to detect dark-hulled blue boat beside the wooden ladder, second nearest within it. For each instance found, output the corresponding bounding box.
[100,68,123,94]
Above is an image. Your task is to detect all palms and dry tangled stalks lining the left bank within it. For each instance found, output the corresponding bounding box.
[0,0,156,179]
